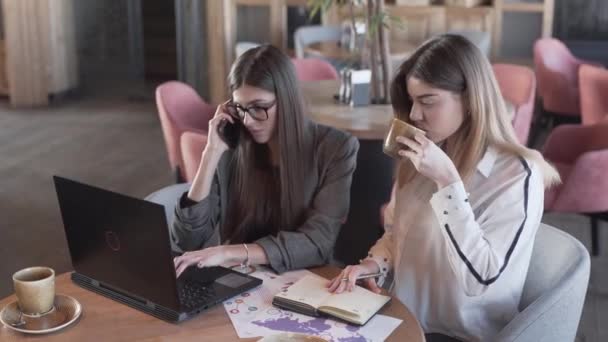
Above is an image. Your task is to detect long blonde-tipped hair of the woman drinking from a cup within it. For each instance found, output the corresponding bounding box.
[391,34,560,187]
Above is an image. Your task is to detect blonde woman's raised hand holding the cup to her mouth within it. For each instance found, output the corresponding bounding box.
[396,133,460,189]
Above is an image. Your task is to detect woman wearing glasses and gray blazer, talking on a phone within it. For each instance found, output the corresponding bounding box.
[171,45,359,276]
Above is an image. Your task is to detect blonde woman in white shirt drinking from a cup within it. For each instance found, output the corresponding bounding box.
[328,35,559,341]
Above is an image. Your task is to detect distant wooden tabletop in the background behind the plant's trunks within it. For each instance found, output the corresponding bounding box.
[304,41,417,61]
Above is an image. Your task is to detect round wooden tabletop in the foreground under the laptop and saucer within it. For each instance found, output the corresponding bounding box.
[0,266,424,342]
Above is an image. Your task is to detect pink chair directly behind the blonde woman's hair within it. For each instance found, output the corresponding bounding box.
[492,64,536,145]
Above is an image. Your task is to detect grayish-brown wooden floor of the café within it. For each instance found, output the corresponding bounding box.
[0,89,608,342]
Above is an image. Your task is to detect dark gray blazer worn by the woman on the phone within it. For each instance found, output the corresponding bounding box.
[171,124,359,273]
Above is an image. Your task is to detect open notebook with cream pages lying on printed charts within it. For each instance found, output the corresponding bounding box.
[272,275,391,325]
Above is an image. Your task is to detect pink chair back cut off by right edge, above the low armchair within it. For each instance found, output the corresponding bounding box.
[578,64,608,125]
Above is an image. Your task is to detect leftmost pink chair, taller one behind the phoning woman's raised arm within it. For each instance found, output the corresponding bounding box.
[156,81,215,183]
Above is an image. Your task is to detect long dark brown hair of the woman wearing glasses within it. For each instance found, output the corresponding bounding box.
[222,45,312,243]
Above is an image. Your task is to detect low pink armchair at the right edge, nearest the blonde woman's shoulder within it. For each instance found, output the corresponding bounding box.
[543,120,608,256]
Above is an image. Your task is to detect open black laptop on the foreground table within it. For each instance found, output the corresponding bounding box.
[53,176,262,323]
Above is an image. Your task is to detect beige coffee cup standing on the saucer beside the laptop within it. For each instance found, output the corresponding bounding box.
[13,266,55,316]
